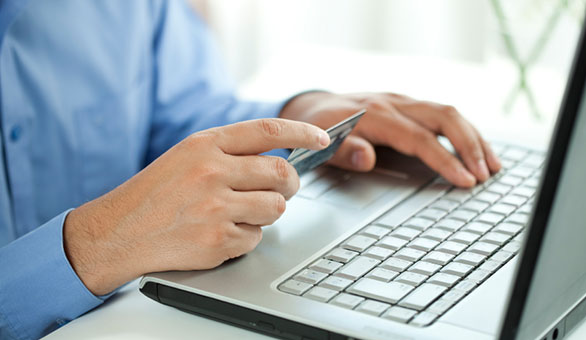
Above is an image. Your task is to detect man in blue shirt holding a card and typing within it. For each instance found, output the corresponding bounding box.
[0,0,500,339]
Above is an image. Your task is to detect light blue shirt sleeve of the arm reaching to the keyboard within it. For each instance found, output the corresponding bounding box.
[146,1,286,163]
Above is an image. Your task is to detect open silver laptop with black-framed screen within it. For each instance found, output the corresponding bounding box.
[140,16,586,340]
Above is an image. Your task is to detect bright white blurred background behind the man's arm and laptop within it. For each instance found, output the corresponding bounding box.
[190,0,586,146]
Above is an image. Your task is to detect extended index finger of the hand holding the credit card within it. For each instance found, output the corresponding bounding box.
[216,118,330,155]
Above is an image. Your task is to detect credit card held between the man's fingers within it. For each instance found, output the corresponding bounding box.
[287,110,366,176]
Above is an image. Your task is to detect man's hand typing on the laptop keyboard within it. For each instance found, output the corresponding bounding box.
[281,92,501,187]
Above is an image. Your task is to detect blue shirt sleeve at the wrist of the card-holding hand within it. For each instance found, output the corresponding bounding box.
[0,211,108,339]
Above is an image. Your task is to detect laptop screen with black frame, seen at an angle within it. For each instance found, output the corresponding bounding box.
[501,17,586,340]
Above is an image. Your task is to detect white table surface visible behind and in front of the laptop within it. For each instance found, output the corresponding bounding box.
[45,47,586,340]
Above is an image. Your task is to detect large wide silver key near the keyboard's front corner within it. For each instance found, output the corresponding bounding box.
[347,279,414,304]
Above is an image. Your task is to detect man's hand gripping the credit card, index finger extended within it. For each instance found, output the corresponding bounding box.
[64,119,330,295]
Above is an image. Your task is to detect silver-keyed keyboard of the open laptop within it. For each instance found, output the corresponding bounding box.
[278,145,544,327]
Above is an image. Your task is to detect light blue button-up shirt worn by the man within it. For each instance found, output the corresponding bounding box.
[0,0,283,339]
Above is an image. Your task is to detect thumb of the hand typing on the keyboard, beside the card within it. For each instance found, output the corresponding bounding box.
[329,135,376,172]
